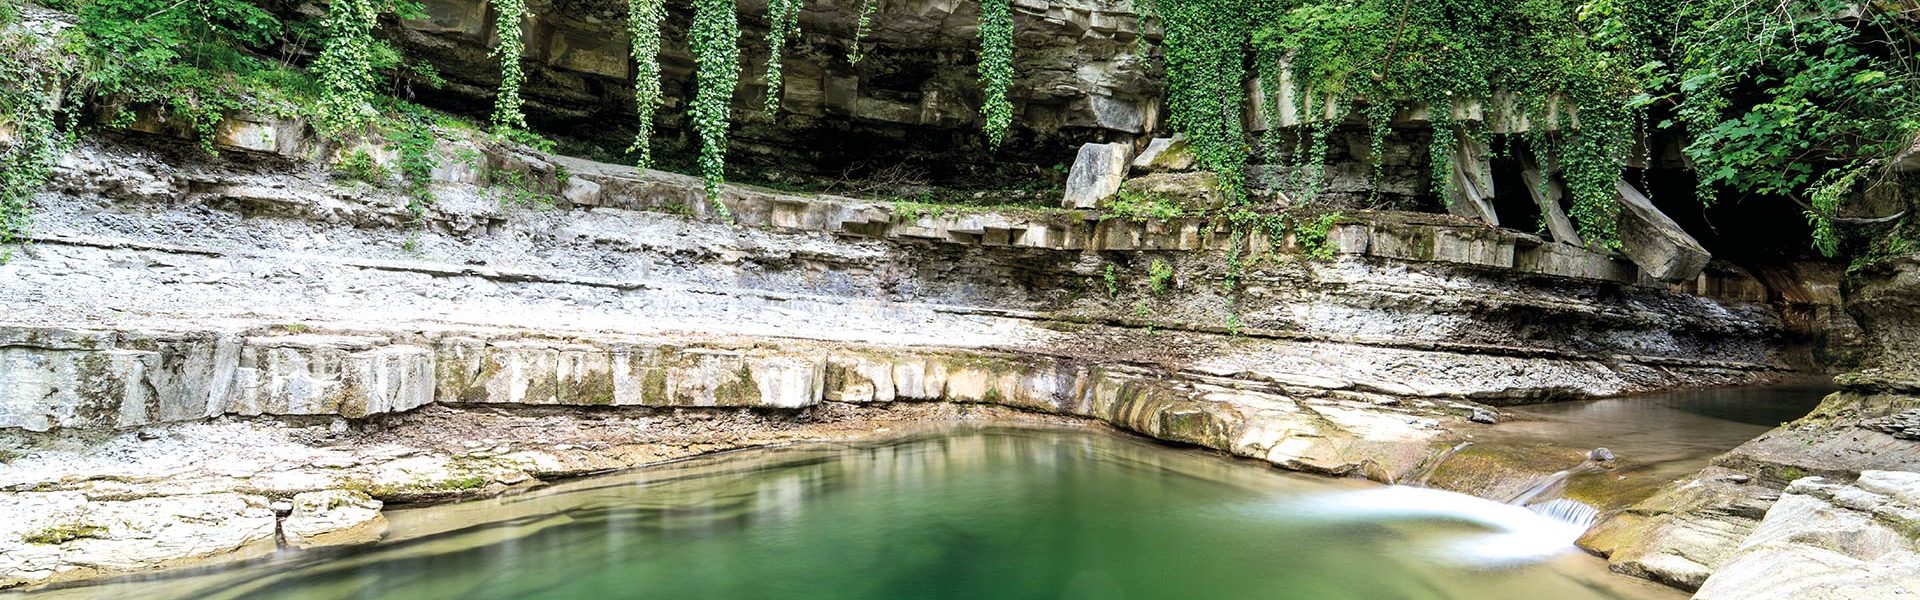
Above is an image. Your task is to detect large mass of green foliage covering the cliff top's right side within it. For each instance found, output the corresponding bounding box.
[1154,0,1920,254]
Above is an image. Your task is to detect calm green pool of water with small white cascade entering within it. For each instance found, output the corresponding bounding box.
[33,429,1682,600]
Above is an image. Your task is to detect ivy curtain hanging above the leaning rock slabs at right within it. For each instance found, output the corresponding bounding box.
[1256,0,1659,240]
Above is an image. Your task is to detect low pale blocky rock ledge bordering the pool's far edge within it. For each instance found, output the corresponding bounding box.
[0,335,1473,587]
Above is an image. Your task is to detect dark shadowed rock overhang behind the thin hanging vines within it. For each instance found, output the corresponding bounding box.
[392,0,1164,179]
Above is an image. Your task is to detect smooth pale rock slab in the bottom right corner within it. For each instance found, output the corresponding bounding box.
[1693,471,1920,600]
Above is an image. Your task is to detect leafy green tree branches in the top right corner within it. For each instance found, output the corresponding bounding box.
[1681,0,1920,213]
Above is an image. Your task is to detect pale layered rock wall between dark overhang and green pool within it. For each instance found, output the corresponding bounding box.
[0,125,1820,587]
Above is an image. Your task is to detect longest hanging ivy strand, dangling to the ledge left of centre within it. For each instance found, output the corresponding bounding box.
[687,0,739,215]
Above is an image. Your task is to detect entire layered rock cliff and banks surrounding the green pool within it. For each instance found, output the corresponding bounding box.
[0,0,1896,598]
